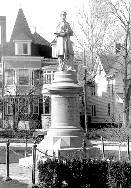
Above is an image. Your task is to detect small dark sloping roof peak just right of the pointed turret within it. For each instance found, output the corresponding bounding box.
[33,32,50,46]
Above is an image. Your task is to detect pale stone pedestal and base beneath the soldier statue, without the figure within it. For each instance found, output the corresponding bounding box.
[37,70,84,155]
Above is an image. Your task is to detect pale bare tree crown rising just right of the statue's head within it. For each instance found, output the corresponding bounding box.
[74,0,110,66]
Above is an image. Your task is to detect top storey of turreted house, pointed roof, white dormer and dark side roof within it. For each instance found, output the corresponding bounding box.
[1,9,52,58]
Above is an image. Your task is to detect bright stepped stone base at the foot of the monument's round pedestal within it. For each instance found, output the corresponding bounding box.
[19,135,83,167]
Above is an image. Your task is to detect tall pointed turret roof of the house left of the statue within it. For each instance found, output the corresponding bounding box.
[10,8,33,42]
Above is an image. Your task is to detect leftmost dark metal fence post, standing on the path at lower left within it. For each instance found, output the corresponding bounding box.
[5,139,12,181]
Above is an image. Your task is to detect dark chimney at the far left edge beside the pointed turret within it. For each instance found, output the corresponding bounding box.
[0,16,6,45]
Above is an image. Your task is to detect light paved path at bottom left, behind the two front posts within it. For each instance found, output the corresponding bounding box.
[0,163,38,188]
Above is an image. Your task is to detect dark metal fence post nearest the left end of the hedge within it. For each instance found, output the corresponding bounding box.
[32,141,37,188]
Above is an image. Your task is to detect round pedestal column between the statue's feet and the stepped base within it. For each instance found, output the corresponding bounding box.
[47,70,82,144]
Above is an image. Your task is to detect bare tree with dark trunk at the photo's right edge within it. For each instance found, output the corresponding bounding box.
[107,0,131,127]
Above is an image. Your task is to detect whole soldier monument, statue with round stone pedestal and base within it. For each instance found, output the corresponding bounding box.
[37,12,83,155]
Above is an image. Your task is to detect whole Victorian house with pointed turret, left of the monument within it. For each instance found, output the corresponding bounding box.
[0,9,53,128]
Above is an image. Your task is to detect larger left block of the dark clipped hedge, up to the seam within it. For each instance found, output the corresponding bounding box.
[38,159,108,188]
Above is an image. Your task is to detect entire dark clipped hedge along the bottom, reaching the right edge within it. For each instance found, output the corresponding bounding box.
[38,159,131,188]
